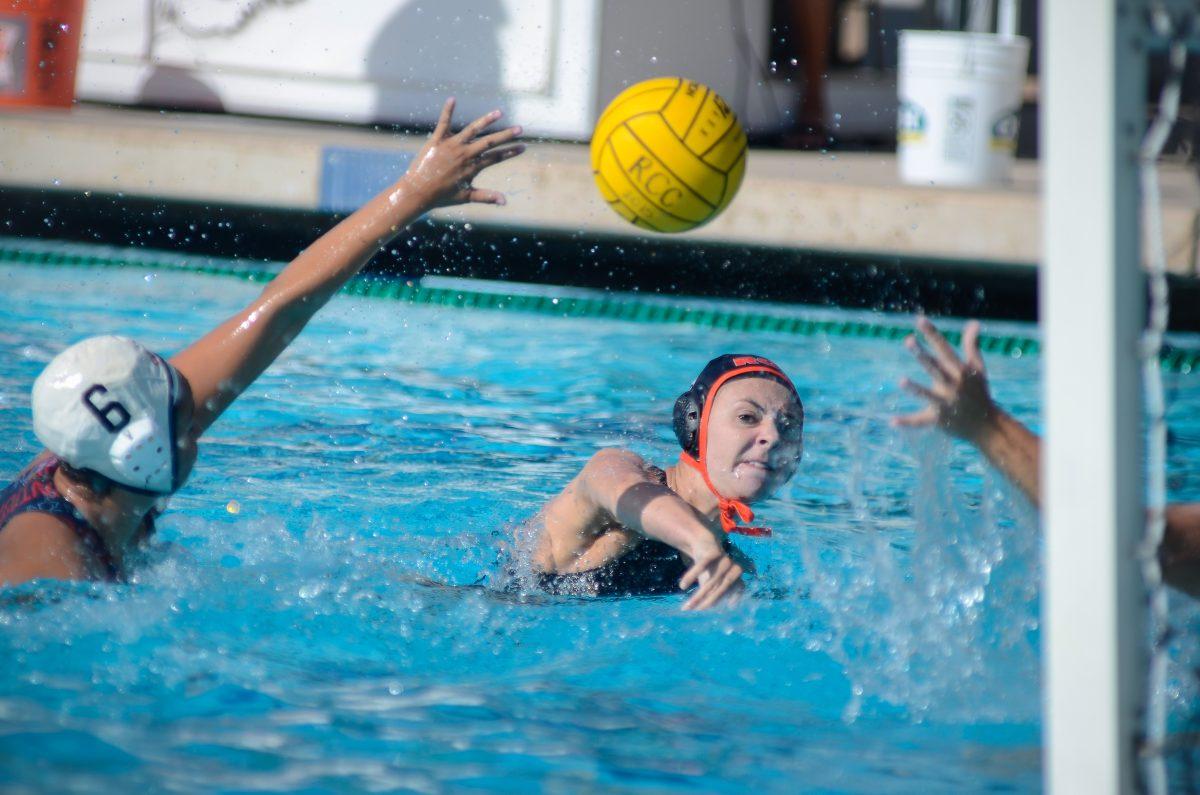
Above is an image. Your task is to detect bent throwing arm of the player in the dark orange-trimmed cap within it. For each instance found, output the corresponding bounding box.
[577,448,743,610]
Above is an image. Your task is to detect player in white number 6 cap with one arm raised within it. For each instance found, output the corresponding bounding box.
[0,100,522,585]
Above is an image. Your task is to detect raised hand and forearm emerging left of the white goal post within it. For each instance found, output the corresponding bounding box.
[892,317,1042,506]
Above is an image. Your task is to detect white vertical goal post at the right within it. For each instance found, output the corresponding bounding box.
[1039,0,1200,794]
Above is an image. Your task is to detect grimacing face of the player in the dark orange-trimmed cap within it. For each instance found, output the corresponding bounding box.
[704,376,804,502]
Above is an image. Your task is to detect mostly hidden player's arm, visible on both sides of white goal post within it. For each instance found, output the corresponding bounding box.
[893,317,1200,597]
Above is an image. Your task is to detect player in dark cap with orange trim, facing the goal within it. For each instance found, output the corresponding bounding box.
[517,354,804,609]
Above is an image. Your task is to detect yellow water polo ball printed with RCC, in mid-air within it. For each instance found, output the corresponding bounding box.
[592,77,746,232]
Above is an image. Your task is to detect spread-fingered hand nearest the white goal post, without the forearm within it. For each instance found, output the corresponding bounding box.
[892,317,997,441]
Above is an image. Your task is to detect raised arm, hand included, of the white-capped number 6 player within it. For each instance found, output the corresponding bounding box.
[170,100,523,436]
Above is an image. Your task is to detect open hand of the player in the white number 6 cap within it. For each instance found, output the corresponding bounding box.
[404,98,524,207]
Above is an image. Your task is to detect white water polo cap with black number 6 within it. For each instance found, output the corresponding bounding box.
[34,336,181,494]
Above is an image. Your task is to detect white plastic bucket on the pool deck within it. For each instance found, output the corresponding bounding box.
[896,30,1030,185]
